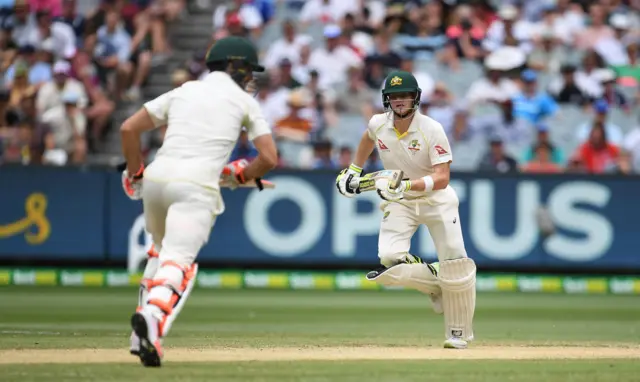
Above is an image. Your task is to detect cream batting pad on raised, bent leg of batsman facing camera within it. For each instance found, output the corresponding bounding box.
[367,263,441,295]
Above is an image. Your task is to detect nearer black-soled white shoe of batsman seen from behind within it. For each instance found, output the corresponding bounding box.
[131,310,163,367]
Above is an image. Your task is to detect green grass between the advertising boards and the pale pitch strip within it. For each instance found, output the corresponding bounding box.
[0,287,640,349]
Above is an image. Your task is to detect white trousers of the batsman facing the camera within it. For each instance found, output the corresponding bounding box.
[378,187,467,267]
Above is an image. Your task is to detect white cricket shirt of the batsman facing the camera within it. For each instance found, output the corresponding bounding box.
[367,112,453,199]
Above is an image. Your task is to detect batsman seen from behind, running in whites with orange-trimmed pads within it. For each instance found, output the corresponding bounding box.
[121,37,277,367]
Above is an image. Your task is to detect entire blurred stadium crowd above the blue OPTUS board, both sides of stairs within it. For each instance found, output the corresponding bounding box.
[0,0,640,174]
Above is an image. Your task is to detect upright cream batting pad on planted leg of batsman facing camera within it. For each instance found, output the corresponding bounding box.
[438,257,476,340]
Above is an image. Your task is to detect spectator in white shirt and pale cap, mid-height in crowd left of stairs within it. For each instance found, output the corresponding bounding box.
[36,61,88,116]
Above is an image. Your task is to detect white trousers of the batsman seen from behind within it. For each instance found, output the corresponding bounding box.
[142,179,221,267]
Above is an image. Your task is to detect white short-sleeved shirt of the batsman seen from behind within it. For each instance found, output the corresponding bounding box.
[144,72,271,190]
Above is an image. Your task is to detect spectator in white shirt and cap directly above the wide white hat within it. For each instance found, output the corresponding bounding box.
[482,4,533,53]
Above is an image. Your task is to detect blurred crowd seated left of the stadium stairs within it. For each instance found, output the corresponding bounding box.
[0,0,185,165]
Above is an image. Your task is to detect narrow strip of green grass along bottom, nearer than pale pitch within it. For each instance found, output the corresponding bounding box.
[0,360,640,382]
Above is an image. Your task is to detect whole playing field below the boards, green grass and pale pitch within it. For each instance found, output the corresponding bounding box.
[0,287,640,382]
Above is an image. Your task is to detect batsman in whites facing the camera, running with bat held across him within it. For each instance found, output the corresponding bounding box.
[336,71,476,349]
